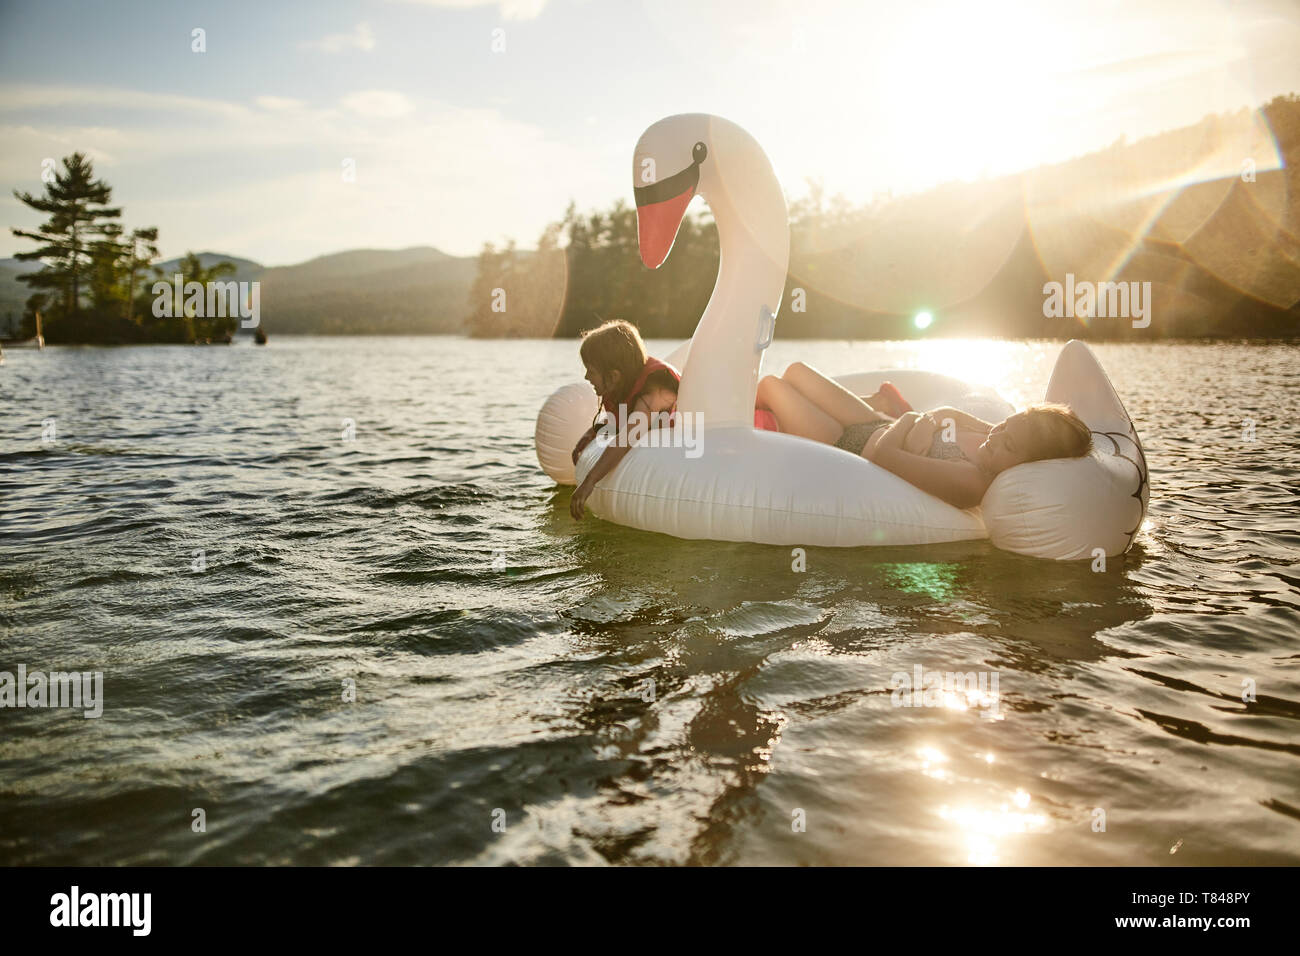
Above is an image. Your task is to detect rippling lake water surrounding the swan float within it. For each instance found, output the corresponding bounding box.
[0,337,1300,865]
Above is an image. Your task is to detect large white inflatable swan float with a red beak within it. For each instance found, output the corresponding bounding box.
[534,113,1148,561]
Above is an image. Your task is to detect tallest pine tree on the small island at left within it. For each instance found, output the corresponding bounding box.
[10,152,122,325]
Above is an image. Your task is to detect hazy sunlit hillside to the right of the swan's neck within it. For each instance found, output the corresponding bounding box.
[783,96,1300,339]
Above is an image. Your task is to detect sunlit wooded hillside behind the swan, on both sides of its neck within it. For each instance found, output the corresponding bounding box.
[469,94,1300,341]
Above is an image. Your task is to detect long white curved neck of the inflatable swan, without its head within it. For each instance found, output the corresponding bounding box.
[677,143,790,428]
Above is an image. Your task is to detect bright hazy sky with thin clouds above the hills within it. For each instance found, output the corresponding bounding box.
[0,0,1300,265]
